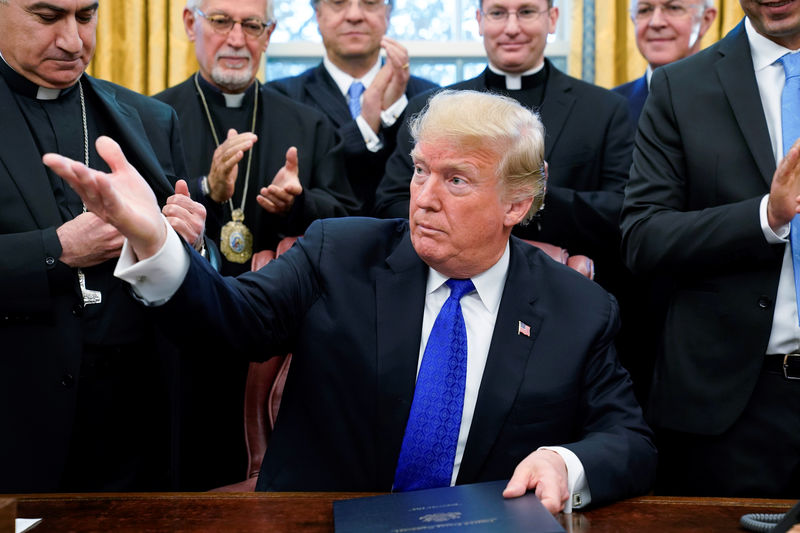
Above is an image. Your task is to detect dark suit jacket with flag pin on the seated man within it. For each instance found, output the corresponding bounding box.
[161,217,655,503]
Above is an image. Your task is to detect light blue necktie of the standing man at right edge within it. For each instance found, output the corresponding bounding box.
[779,53,800,324]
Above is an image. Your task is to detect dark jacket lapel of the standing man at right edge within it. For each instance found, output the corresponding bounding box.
[716,21,775,185]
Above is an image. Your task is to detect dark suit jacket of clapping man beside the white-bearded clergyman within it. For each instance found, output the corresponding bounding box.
[269,63,438,215]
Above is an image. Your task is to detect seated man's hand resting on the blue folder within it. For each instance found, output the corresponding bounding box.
[503,450,569,514]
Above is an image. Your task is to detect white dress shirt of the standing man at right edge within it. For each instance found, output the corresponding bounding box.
[745,18,800,353]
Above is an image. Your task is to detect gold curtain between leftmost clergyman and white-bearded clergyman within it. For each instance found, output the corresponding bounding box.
[88,0,197,95]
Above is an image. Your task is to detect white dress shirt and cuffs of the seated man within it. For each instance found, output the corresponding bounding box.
[119,228,591,513]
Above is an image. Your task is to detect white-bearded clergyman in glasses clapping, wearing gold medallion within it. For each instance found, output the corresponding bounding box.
[154,0,358,275]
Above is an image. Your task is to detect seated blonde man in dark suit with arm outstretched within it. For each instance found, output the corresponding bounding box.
[45,91,655,512]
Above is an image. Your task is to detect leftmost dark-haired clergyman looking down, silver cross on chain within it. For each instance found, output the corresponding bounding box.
[0,0,205,492]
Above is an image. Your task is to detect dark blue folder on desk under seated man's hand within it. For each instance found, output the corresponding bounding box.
[333,481,564,533]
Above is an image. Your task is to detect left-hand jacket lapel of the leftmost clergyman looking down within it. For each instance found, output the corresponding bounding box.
[0,77,63,228]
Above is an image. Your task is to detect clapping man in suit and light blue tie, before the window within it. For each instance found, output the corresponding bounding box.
[269,0,436,214]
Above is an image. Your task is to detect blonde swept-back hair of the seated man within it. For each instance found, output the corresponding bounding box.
[409,90,546,223]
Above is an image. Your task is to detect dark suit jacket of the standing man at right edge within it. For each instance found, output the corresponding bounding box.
[622,23,784,434]
